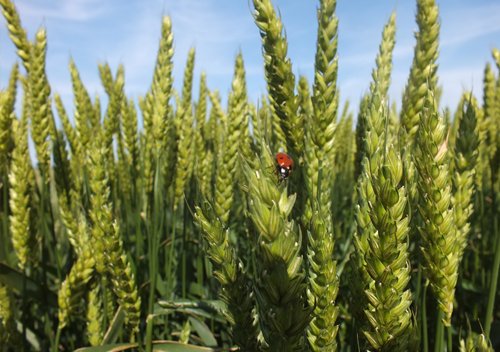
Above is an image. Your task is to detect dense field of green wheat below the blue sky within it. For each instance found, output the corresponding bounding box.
[0,0,500,352]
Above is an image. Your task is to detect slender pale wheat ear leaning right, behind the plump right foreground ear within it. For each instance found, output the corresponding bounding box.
[351,14,396,334]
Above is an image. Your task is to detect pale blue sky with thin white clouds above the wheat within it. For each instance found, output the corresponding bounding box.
[0,0,500,119]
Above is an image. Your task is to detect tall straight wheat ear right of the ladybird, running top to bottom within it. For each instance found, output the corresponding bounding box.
[299,0,339,351]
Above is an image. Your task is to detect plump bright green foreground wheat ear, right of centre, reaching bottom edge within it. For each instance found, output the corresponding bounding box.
[363,146,412,351]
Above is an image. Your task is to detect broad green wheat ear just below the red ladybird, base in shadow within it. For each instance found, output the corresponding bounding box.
[242,144,312,351]
